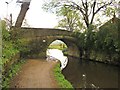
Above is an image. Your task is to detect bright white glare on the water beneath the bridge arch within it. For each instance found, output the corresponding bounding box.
[46,49,68,70]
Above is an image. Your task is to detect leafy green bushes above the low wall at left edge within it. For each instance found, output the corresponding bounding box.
[0,20,28,65]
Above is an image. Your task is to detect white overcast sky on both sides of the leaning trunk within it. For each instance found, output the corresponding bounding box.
[0,0,58,28]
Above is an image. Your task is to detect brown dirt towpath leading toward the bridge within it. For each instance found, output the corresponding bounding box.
[10,59,58,88]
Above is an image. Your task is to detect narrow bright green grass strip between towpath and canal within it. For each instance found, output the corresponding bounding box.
[54,63,73,90]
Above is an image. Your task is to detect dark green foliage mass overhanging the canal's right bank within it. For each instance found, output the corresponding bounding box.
[73,18,120,64]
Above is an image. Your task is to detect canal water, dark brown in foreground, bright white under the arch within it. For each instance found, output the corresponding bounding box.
[46,50,120,88]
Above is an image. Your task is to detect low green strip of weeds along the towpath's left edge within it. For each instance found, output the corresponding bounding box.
[2,60,25,90]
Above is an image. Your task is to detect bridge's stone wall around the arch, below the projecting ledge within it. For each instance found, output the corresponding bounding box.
[24,36,80,58]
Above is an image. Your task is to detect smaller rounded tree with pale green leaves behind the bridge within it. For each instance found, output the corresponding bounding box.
[54,6,83,31]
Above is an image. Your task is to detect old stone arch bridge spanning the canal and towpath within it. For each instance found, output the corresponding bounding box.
[13,27,80,58]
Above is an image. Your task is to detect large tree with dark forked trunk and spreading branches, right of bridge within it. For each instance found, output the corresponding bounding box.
[43,0,118,58]
